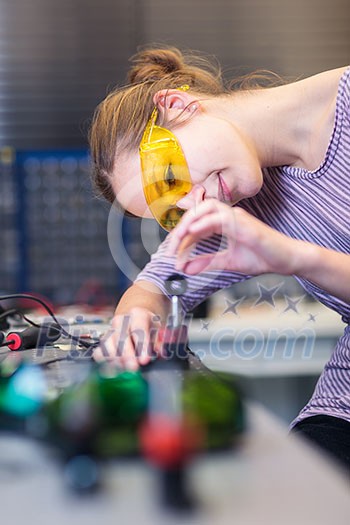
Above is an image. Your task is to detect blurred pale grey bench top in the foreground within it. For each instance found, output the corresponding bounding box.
[0,403,350,525]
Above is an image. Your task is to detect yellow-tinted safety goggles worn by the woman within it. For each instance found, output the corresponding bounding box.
[139,86,192,231]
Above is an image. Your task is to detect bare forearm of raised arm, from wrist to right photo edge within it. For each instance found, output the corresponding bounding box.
[295,241,350,303]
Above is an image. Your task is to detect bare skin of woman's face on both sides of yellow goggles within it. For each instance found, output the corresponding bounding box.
[112,112,263,217]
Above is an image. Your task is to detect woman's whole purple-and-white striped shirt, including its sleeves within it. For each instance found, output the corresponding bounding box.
[137,68,350,424]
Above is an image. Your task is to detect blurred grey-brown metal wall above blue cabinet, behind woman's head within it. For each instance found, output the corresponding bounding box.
[0,0,350,148]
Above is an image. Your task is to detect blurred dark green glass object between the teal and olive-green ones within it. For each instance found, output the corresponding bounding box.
[45,367,147,457]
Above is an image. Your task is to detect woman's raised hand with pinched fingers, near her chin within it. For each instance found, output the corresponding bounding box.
[168,199,302,275]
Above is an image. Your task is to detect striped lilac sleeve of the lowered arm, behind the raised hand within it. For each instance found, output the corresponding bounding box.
[135,235,250,313]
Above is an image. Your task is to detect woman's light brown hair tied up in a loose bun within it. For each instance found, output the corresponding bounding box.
[89,47,284,210]
